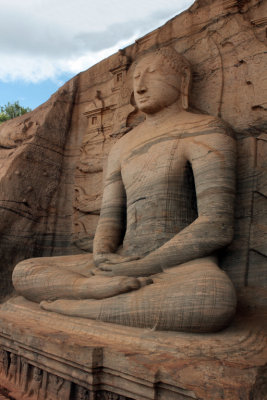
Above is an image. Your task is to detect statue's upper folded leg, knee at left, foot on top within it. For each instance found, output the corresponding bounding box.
[12,254,149,303]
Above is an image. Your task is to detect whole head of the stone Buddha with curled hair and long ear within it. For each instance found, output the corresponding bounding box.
[133,47,191,114]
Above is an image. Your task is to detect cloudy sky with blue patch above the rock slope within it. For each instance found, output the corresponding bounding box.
[0,0,193,109]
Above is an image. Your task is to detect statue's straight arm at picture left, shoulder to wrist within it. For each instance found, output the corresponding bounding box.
[93,145,126,265]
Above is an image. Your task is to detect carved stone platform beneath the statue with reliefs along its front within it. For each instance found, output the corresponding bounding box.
[0,297,267,400]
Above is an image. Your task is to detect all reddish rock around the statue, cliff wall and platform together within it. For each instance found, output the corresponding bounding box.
[0,0,267,400]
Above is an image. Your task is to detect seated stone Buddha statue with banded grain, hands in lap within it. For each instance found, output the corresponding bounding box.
[13,48,239,332]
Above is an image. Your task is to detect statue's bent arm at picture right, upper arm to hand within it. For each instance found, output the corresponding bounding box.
[99,127,236,276]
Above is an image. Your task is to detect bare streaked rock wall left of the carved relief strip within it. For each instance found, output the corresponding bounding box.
[0,78,80,296]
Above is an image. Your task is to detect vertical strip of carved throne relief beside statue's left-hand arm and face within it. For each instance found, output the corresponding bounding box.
[73,50,134,250]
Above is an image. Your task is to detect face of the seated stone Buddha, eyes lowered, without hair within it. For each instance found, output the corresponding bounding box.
[133,55,181,114]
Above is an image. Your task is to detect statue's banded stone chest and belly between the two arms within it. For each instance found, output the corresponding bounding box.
[121,120,197,256]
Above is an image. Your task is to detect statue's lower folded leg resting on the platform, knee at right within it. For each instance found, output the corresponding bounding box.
[38,258,236,332]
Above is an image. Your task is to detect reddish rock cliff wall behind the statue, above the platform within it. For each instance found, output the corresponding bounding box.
[0,0,267,296]
